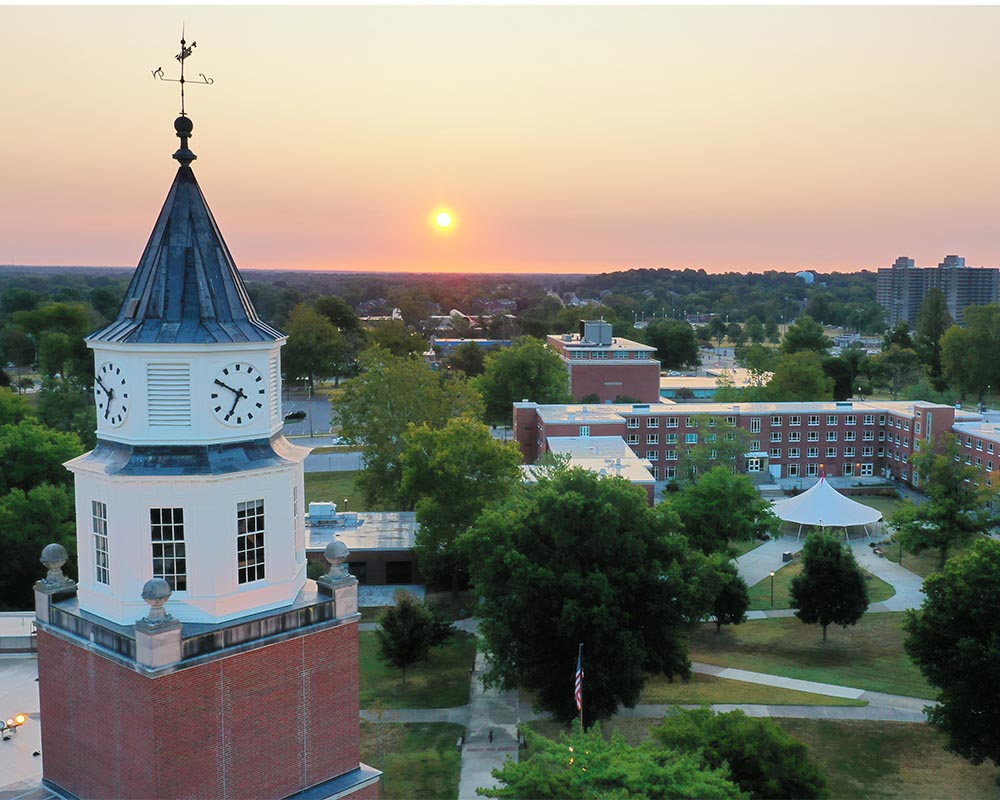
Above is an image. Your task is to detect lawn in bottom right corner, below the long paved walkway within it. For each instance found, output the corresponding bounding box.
[530,717,1000,800]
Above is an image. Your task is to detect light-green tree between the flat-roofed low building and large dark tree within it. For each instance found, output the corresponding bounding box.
[401,418,521,598]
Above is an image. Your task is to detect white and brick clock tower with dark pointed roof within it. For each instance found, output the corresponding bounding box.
[36,65,379,800]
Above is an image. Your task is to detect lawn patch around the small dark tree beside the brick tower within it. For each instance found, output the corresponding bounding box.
[358,631,476,708]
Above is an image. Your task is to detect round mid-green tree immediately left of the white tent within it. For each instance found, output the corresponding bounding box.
[670,466,780,557]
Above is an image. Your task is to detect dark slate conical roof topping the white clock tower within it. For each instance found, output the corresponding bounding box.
[88,166,284,344]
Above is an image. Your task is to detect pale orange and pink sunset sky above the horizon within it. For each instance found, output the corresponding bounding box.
[0,6,1000,272]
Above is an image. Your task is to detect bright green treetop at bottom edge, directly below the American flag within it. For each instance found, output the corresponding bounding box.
[476,722,743,800]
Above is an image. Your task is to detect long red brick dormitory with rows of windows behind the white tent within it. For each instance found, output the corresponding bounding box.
[514,401,1000,502]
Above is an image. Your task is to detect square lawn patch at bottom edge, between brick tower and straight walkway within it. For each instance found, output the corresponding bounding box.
[361,712,465,800]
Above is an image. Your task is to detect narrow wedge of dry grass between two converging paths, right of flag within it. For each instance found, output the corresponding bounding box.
[639,676,868,706]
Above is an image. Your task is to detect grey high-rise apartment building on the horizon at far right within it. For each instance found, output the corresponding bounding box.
[875,255,1000,328]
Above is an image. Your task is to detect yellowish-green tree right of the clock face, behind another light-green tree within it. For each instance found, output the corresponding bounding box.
[334,347,482,508]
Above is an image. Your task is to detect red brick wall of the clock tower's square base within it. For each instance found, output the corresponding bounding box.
[38,624,368,800]
